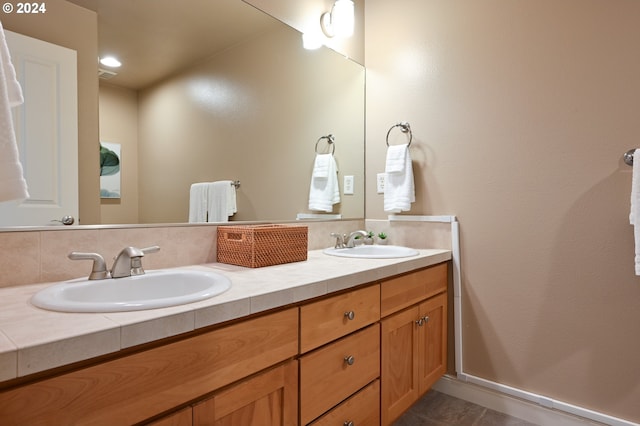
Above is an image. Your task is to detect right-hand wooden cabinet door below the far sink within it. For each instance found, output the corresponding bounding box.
[418,293,447,395]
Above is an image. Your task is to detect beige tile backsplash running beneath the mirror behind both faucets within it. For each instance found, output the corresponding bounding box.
[0,219,451,287]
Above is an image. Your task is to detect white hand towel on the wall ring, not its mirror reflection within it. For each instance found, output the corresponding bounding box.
[384,144,416,213]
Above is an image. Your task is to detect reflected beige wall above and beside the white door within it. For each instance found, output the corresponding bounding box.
[2,0,100,224]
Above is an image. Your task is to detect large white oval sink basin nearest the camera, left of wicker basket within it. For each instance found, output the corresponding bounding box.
[31,269,231,312]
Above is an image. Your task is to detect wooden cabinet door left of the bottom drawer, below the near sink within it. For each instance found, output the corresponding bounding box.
[193,361,298,426]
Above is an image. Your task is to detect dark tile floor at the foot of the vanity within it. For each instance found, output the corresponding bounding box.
[394,390,536,426]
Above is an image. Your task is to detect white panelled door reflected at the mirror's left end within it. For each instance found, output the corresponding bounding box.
[0,31,78,226]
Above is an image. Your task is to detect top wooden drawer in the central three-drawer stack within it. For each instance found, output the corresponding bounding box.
[300,284,380,353]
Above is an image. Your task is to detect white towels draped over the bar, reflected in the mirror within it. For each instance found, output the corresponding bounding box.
[189,180,238,223]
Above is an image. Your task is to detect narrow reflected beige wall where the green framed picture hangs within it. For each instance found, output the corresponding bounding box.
[99,83,140,223]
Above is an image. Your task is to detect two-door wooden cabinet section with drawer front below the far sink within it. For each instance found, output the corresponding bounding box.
[380,264,447,425]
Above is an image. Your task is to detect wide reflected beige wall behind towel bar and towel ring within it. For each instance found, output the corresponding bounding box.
[138,26,364,223]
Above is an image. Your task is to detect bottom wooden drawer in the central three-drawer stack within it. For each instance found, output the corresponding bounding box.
[311,380,380,426]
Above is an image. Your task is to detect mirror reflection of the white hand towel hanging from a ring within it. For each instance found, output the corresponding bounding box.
[309,154,340,212]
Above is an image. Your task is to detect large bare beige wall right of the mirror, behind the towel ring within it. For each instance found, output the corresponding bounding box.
[366,0,640,422]
